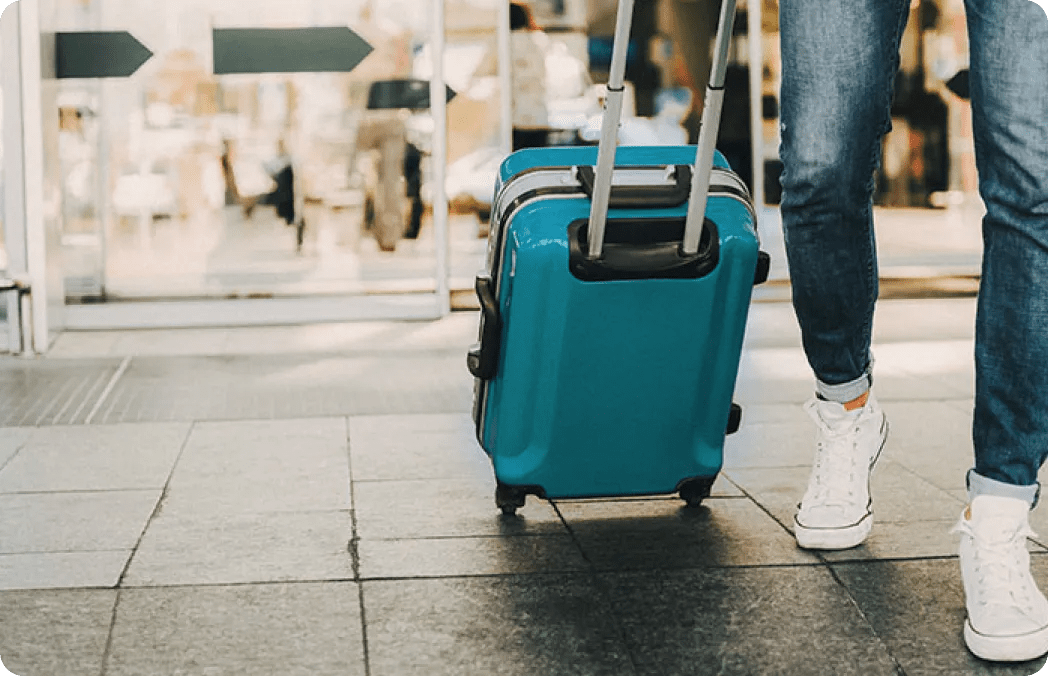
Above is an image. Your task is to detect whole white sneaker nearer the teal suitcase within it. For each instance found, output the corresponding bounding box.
[793,393,888,549]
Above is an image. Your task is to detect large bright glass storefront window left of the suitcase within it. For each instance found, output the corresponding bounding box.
[41,0,456,302]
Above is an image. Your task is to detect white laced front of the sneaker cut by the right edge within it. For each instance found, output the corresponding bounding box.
[951,518,1036,615]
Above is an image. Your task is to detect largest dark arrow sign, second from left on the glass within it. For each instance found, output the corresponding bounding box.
[212,26,372,75]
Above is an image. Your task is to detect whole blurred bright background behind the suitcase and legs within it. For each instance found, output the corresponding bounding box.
[0,0,981,351]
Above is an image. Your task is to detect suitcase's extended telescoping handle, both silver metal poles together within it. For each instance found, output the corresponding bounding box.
[587,0,736,259]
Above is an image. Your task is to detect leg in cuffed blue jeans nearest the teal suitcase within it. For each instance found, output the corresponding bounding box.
[780,0,910,402]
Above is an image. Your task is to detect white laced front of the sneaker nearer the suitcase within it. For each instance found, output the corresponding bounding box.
[805,400,861,507]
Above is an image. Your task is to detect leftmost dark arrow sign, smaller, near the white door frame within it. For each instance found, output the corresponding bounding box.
[54,30,153,80]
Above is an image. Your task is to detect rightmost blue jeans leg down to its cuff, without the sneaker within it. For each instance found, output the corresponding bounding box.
[966,0,1048,503]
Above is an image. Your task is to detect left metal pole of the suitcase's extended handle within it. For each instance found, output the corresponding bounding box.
[588,0,633,259]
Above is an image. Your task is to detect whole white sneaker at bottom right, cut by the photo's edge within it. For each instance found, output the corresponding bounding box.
[953,496,1048,661]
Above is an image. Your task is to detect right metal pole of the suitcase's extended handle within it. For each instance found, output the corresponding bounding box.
[681,0,736,256]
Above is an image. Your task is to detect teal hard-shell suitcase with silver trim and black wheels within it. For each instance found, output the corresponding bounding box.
[467,0,768,514]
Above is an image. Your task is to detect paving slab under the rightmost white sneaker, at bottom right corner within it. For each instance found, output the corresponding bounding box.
[833,554,1048,676]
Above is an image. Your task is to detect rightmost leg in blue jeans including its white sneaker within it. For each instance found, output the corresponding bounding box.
[957,0,1048,660]
